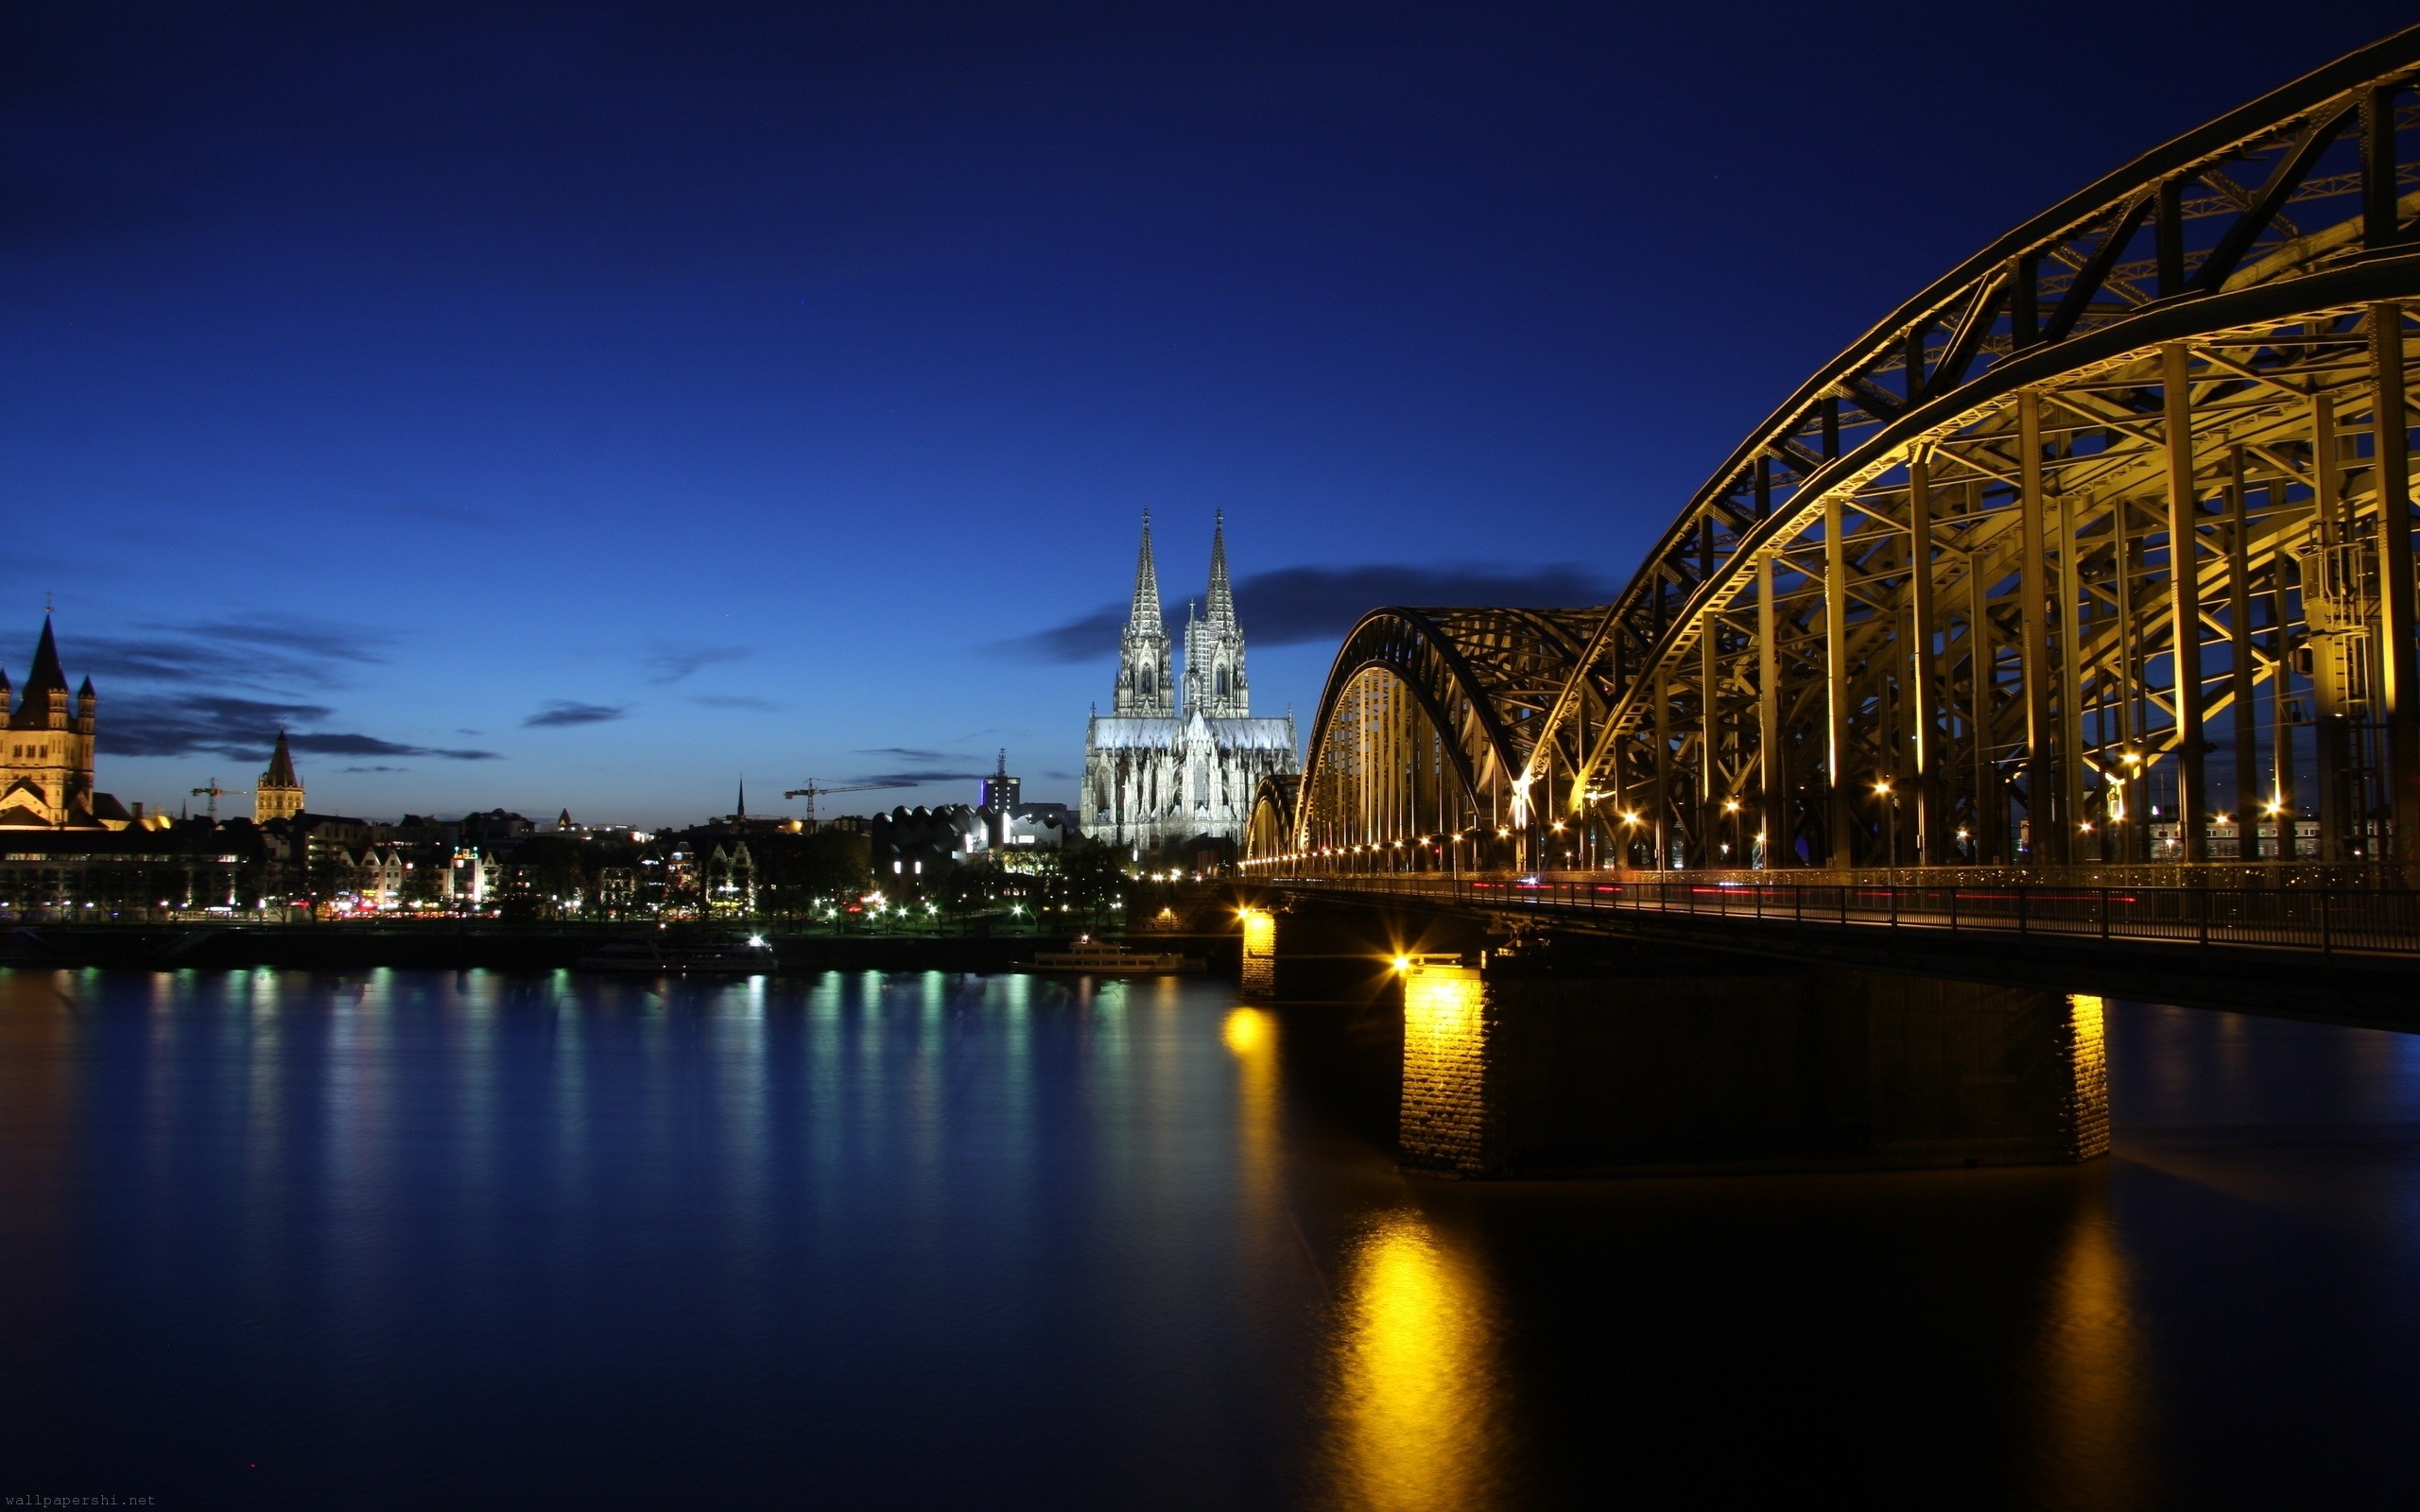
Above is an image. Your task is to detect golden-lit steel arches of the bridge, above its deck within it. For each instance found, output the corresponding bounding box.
[1246,26,2420,871]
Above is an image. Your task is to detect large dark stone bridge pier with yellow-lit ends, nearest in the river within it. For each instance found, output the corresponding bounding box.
[1396,949,2108,1178]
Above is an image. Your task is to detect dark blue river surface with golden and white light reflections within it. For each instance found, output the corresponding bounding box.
[0,972,2420,1512]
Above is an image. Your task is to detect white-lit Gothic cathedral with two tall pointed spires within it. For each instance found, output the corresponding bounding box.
[1080,515,1300,856]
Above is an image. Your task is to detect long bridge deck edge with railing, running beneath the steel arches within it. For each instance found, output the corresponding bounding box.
[1266,873,2420,955]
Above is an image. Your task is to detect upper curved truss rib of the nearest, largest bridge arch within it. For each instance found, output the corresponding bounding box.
[1548,26,2420,802]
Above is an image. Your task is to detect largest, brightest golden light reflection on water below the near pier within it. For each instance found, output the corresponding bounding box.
[1334,1207,1508,1512]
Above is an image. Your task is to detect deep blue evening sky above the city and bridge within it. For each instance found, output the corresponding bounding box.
[0,0,2411,822]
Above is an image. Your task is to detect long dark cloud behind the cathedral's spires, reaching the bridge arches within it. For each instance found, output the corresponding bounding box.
[994,561,1619,662]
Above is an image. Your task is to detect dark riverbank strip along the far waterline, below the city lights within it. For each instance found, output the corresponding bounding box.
[0,919,1241,975]
